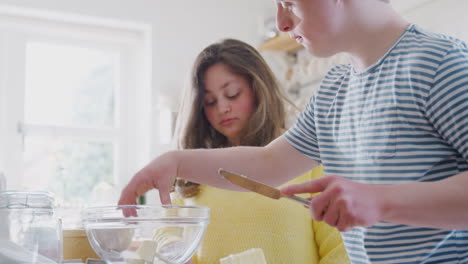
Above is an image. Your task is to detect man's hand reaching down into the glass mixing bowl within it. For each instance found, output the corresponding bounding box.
[119,151,178,205]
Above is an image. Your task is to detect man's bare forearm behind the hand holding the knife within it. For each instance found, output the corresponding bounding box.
[381,171,468,230]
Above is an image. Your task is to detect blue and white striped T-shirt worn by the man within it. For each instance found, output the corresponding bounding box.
[285,25,468,264]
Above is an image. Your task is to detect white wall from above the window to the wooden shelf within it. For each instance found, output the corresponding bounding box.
[0,0,274,104]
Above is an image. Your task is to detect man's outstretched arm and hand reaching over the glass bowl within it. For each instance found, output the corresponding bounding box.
[119,137,318,204]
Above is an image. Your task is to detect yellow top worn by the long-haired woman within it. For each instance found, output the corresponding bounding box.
[174,168,350,264]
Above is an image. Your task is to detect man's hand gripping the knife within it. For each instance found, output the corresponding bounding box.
[281,176,383,232]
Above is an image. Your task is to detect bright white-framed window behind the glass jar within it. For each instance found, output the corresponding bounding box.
[0,7,151,205]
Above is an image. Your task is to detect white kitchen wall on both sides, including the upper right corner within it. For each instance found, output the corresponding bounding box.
[0,0,468,152]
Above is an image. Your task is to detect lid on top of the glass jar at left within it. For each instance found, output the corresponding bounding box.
[0,191,53,209]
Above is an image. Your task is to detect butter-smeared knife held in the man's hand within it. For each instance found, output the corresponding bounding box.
[218,168,310,208]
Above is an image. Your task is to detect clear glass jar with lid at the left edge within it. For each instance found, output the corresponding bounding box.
[0,191,62,264]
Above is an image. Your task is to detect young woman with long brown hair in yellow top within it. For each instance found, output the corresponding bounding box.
[173,39,348,264]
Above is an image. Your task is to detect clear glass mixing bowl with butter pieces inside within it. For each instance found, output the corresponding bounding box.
[83,205,210,264]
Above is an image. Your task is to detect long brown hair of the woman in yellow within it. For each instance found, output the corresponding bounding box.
[175,39,289,197]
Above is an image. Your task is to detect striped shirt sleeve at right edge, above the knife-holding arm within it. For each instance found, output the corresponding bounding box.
[426,46,468,160]
